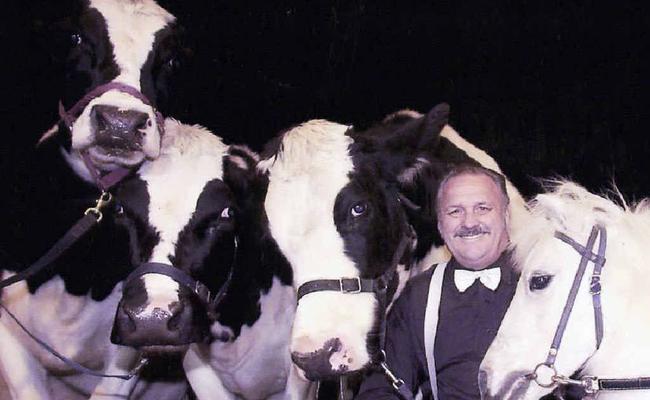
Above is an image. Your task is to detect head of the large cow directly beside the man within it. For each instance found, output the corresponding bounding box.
[258,105,448,380]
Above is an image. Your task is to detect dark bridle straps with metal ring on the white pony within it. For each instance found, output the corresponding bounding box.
[525,225,650,395]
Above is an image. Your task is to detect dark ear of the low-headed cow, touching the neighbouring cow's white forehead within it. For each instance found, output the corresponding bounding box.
[223,145,259,199]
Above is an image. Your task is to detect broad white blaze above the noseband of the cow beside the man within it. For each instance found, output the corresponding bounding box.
[260,120,354,280]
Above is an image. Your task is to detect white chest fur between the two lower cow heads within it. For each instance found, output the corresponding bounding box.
[184,278,295,400]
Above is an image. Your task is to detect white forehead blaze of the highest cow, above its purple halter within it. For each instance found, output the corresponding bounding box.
[90,0,174,86]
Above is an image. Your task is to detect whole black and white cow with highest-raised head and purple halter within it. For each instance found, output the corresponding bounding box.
[0,0,187,399]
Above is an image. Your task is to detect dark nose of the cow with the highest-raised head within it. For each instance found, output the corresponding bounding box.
[90,104,152,150]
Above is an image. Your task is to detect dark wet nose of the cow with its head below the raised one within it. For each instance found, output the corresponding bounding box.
[111,301,203,351]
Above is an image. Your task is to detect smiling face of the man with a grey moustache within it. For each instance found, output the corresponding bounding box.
[438,174,508,270]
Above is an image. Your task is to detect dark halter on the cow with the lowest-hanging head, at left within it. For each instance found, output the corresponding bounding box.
[123,236,239,319]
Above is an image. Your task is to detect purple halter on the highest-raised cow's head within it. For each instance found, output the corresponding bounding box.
[59,82,165,191]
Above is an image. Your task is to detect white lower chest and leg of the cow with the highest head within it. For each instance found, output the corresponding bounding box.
[0,272,126,399]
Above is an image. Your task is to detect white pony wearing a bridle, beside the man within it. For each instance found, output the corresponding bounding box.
[479,181,650,399]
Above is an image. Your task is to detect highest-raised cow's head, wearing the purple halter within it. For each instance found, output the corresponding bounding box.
[41,0,185,178]
